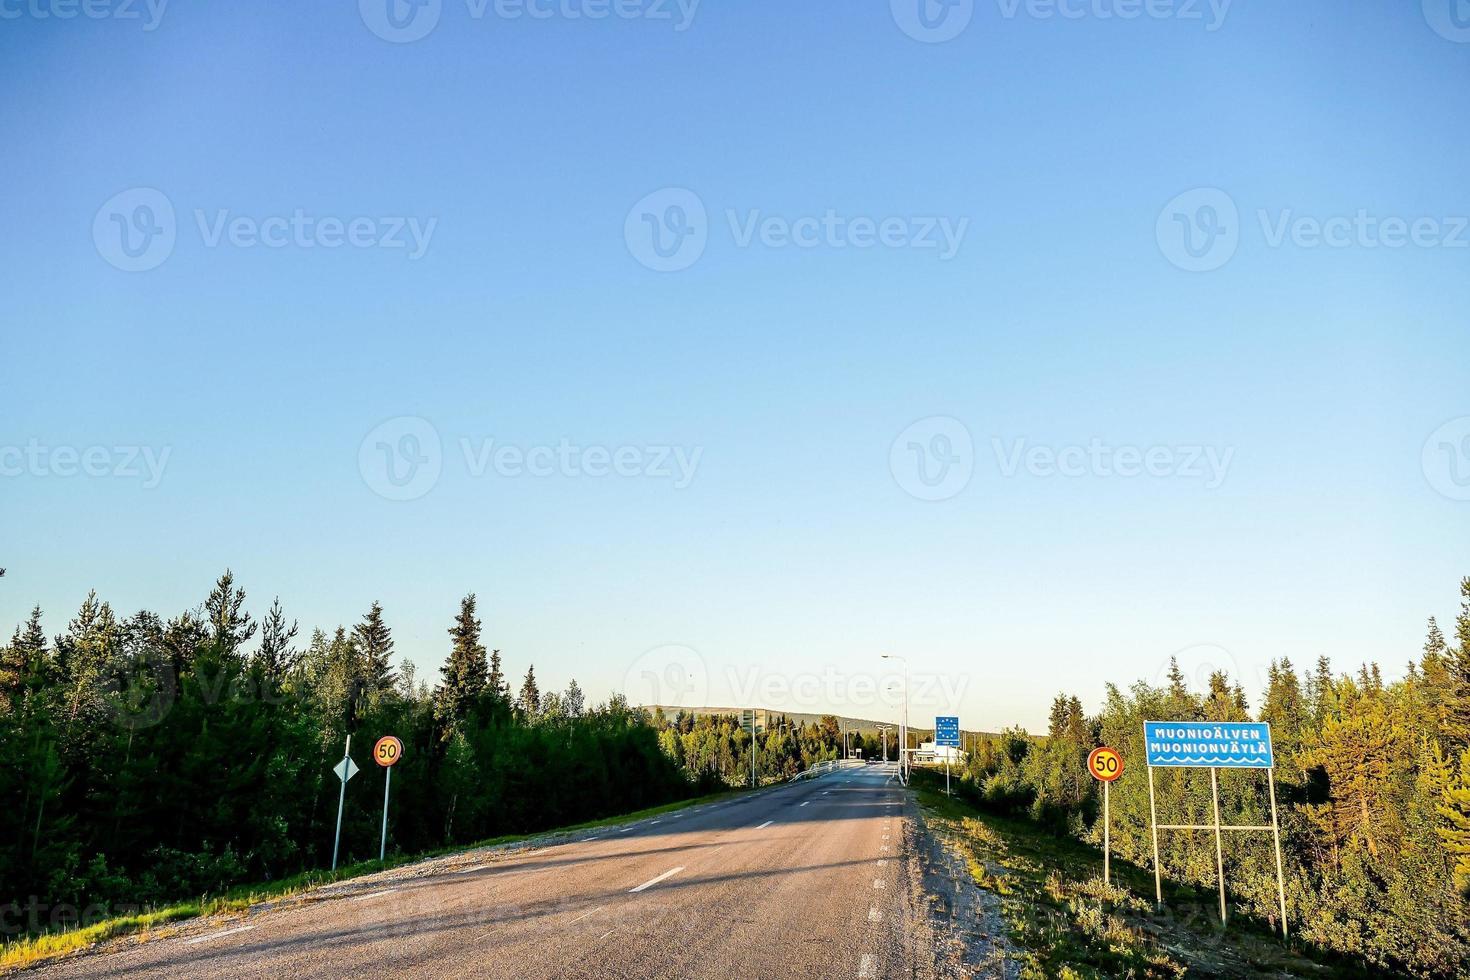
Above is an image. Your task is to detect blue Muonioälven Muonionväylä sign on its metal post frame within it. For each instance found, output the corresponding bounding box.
[1144,721,1286,937]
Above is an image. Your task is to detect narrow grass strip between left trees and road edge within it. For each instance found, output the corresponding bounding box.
[0,789,735,973]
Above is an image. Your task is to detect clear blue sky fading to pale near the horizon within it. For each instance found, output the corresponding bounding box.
[0,0,1470,727]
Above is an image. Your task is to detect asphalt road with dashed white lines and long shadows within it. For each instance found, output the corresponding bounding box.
[35,765,933,980]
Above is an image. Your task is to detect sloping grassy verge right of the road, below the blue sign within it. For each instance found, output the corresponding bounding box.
[913,771,1370,980]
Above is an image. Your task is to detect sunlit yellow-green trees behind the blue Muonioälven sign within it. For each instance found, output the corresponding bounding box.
[958,579,1470,977]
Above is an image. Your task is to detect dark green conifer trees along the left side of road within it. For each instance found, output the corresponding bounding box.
[0,572,693,937]
